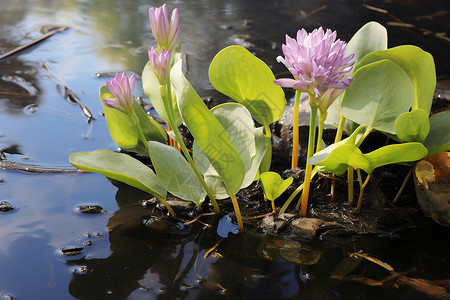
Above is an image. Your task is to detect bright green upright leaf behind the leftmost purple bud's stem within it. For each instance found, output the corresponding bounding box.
[100,85,167,156]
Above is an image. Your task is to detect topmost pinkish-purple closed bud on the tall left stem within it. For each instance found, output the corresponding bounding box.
[148,4,180,50]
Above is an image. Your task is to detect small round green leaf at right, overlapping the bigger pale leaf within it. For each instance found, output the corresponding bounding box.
[395,109,430,143]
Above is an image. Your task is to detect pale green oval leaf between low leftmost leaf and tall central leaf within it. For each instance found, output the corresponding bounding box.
[148,141,206,205]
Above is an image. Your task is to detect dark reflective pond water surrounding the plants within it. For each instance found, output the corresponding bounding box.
[0,0,450,299]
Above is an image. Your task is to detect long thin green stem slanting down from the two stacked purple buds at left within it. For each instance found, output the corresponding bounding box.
[163,80,220,213]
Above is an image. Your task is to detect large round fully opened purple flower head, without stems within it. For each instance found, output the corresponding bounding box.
[274,27,355,106]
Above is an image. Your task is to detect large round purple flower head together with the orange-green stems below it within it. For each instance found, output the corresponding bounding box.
[274,27,354,216]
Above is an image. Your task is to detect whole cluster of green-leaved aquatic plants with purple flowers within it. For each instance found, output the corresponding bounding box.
[70,5,450,230]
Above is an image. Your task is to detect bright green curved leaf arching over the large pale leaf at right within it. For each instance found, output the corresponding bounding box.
[355,45,436,114]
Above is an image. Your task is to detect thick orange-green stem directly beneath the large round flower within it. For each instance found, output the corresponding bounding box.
[297,104,318,217]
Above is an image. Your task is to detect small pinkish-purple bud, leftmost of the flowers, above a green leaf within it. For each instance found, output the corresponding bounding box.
[102,73,136,114]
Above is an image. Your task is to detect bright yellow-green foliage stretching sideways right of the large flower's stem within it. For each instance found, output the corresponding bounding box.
[308,142,428,175]
